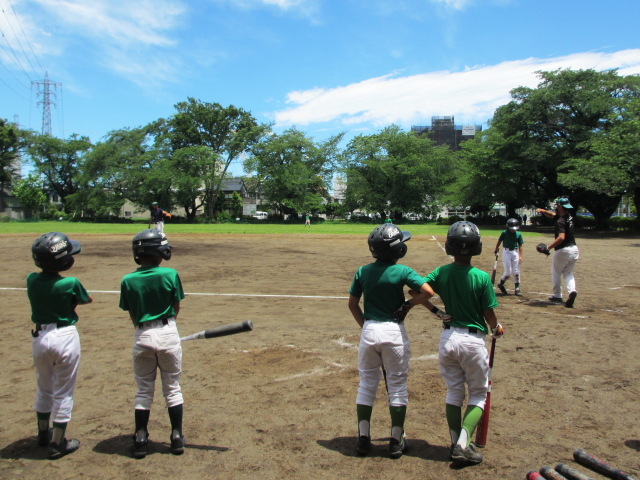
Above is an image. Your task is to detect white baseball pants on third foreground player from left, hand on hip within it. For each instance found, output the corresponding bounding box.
[356,320,411,407]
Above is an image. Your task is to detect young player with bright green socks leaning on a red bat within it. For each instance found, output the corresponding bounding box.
[409,222,504,464]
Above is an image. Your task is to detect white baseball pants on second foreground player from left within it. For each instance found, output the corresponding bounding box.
[133,318,183,410]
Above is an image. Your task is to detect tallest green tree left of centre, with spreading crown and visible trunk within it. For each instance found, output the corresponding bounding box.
[161,98,270,216]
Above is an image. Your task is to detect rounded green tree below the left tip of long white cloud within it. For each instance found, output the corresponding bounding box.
[244,128,343,218]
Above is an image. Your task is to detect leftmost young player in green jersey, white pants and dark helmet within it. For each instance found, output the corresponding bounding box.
[27,232,93,460]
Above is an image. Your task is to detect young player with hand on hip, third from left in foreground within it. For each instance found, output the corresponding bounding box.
[349,223,433,458]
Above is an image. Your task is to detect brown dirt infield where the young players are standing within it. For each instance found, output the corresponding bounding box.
[0,232,640,480]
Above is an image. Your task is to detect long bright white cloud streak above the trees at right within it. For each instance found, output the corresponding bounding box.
[273,49,640,127]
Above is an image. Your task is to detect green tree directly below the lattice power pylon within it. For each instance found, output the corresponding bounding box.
[27,134,92,208]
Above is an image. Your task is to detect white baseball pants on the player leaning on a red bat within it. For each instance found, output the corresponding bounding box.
[438,327,489,409]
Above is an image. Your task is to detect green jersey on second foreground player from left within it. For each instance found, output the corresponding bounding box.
[120,265,184,325]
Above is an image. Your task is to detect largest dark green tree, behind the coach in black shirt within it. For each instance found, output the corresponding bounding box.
[457,70,638,224]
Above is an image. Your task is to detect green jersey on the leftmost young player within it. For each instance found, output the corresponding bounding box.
[27,272,89,327]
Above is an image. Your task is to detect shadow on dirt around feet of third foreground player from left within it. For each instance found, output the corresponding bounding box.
[316,437,449,462]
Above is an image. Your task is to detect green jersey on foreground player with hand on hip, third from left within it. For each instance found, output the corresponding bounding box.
[349,260,424,322]
